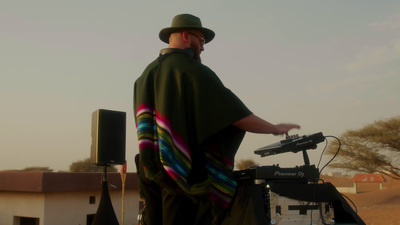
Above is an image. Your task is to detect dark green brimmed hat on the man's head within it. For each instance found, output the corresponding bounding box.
[158,14,215,44]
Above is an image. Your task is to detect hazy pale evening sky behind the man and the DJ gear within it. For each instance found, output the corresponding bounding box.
[0,0,400,172]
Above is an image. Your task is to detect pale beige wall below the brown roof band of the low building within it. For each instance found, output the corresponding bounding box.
[0,190,139,225]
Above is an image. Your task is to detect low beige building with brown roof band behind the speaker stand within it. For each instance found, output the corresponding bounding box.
[0,171,139,225]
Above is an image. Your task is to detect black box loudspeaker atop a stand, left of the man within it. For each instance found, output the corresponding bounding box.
[90,109,126,165]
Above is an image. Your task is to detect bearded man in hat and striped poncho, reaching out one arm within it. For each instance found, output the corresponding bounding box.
[134,14,300,225]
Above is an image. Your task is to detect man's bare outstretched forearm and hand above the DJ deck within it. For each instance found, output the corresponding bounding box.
[233,114,300,135]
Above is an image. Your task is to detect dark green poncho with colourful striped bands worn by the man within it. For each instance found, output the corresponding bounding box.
[134,49,251,214]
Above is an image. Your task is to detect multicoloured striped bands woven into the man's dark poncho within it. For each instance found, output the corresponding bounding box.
[136,105,236,209]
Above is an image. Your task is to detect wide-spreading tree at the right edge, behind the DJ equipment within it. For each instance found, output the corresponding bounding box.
[327,116,400,179]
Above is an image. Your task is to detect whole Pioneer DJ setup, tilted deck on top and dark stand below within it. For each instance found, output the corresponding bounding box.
[228,132,365,225]
